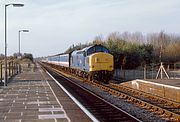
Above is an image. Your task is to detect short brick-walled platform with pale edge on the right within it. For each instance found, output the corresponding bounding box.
[121,79,180,103]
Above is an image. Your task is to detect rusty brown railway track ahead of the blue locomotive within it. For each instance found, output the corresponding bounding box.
[92,82,180,121]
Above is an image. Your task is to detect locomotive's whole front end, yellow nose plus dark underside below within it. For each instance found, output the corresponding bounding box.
[89,52,114,83]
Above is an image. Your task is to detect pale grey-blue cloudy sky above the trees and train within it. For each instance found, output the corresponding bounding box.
[0,0,180,57]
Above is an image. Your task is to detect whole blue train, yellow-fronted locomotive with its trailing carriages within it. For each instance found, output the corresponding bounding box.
[45,45,114,83]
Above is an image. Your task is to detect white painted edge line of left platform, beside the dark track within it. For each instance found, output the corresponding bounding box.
[46,71,99,122]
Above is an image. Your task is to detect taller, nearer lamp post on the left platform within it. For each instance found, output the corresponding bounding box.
[4,3,24,86]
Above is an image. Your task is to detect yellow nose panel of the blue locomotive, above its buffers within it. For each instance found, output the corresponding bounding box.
[89,52,113,71]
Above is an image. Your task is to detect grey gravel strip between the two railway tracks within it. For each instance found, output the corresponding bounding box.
[69,79,167,122]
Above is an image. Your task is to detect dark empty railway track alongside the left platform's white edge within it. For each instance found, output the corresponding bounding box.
[40,62,140,122]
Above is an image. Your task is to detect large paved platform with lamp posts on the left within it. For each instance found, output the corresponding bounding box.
[0,61,92,122]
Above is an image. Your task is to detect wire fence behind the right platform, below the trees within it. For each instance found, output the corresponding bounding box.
[113,64,180,81]
